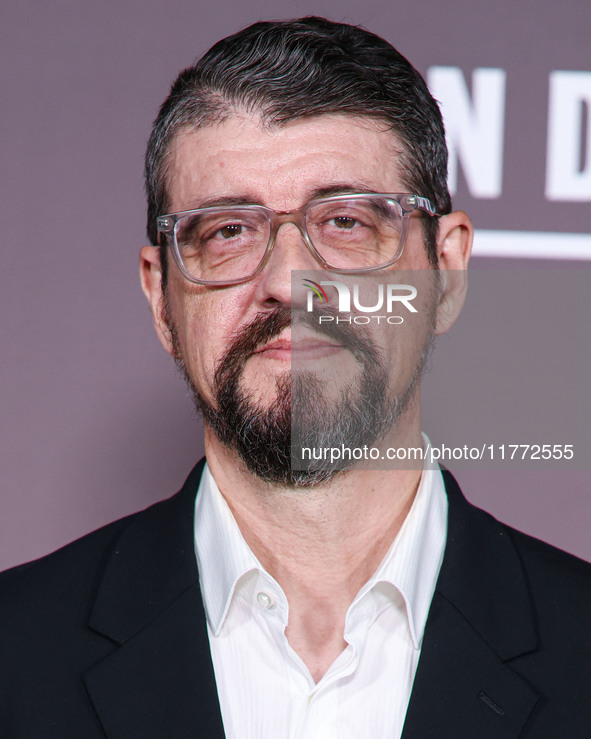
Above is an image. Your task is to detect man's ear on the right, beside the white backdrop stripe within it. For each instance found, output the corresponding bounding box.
[435,210,474,334]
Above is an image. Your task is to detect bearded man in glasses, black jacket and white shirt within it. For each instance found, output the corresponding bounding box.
[0,18,591,739]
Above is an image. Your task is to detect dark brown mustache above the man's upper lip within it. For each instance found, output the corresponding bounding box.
[214,305,381,389]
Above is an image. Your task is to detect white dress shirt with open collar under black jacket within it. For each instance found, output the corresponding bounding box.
[195,465,447,739]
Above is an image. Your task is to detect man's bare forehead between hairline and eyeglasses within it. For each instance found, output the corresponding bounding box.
[167,115,407,211]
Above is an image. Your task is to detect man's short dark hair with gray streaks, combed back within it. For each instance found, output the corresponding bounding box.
[145,17,451,279]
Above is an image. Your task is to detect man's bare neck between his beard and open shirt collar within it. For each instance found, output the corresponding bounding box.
[207,430,421,584]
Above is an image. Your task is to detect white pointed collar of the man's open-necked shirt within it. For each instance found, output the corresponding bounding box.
[195,440,447,649]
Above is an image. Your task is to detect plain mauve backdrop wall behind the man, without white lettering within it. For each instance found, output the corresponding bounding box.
[0,0,591,568]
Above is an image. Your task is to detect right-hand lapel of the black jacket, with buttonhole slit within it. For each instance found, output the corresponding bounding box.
[402,473,539,739]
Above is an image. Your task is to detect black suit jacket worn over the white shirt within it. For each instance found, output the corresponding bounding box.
[0,463,591,739]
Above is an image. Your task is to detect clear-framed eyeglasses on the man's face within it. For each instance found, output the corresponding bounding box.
[156,193,438,286]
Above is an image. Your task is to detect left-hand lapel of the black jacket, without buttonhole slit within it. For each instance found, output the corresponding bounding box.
[85,464,224,739]
